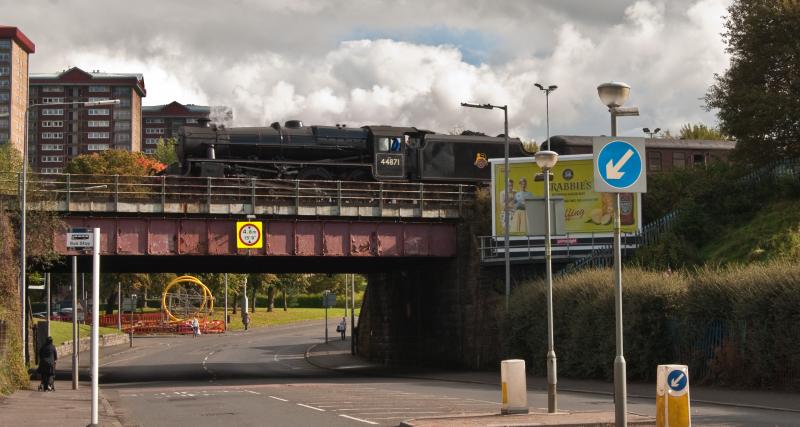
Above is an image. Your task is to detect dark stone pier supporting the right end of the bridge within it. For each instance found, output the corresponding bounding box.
[358,224,503,368]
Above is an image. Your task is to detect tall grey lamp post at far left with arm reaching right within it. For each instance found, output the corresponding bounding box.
[19,99,119,363]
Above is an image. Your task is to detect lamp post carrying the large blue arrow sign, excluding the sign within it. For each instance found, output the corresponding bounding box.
[597,82,639,427]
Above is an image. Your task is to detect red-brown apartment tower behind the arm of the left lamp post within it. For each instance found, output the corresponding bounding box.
[29,67,147,173]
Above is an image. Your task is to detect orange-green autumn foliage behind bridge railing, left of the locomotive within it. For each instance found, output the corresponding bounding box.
[64,150,165,176]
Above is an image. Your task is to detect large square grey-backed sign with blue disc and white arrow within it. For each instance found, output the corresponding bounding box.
[592,138,647,193]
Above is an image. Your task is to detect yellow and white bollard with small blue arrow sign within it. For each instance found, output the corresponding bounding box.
[656,365,692,427]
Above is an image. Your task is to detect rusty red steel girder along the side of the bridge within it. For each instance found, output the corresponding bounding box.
[54,216,456,258]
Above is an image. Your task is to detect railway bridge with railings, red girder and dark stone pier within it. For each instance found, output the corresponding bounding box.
[15,174,564,366]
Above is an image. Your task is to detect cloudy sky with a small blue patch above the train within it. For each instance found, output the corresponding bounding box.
[0,0,730,144]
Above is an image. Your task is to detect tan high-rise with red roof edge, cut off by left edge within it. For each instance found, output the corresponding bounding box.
[0,25,36,154]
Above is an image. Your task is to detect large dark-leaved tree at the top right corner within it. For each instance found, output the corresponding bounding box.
[705,0,800,164]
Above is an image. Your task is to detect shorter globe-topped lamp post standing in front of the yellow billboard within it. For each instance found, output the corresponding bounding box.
[534,148,558,414]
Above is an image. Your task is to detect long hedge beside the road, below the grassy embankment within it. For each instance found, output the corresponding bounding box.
[503,261,800,390]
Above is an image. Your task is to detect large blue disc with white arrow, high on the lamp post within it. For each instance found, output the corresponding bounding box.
[597,141,642,190]
